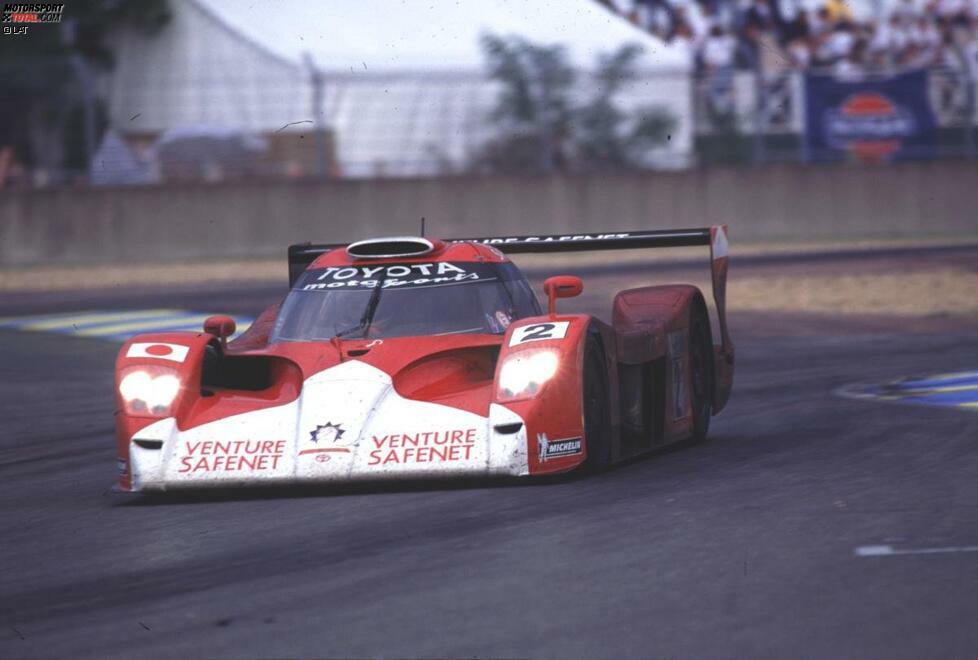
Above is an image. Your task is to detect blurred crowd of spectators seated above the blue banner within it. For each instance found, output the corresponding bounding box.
[601,0,978,76]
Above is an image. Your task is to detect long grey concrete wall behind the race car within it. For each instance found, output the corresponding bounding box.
[0,162,978,267]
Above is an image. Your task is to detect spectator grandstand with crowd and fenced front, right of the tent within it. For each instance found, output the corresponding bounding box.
[595,0,978,163]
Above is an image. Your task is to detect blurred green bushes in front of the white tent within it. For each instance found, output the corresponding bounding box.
[475,35,676,174]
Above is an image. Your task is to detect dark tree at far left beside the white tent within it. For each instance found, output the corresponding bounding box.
[0,0,170,182]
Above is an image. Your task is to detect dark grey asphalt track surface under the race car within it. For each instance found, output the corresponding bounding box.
[0,254,978,659]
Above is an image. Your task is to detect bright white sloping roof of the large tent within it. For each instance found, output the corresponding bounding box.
[199,0,685,73]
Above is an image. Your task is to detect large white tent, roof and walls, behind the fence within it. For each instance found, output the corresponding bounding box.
[108,0,692,176]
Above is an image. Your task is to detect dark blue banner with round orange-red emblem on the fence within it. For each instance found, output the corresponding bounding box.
[805,69,937,161]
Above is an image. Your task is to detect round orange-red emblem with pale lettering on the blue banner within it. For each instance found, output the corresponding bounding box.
[825,92,918,160]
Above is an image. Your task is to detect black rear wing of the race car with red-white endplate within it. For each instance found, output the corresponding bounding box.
[289,225,733,354]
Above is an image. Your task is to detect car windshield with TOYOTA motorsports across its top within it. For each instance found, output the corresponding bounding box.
[271,262,540,342]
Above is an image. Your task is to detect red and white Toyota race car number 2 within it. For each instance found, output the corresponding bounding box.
[115,226,734,491]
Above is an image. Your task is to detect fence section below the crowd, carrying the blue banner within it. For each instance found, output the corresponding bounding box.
[693,67,978,163]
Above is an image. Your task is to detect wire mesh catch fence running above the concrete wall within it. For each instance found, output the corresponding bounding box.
[0,63,978,189]
